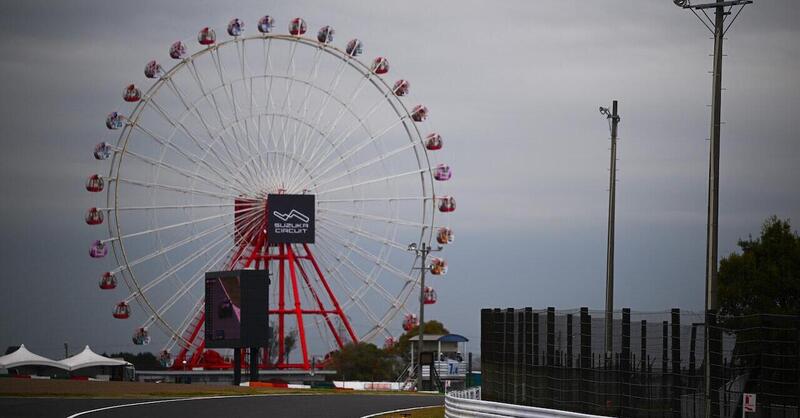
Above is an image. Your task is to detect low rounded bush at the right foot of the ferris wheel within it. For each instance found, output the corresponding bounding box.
[331,342,397,381]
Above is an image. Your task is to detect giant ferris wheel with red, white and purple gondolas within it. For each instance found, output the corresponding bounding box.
[85,16,455,368]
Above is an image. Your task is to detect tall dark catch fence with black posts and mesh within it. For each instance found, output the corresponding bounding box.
[481,308,800,418]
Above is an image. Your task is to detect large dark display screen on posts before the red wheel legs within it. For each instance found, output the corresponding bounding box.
[205,270,269,348]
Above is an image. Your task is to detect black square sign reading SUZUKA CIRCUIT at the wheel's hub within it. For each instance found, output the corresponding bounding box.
[267,194,316,244]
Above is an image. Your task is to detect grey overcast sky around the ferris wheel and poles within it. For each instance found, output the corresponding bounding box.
[0,0,800,357]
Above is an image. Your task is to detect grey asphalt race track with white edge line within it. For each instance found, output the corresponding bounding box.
[0,394,444,418]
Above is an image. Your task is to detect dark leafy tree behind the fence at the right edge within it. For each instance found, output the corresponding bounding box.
[718,216,800,316]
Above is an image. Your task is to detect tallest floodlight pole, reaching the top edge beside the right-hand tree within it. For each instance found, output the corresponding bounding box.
[673,0,753,418]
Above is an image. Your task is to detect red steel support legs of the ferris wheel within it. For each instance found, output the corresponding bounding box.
[173,199,358,373]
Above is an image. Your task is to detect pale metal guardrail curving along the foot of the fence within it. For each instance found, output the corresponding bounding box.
[444,388,606,418]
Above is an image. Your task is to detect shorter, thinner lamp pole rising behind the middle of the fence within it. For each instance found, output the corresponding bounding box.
[600,100,620,354]
